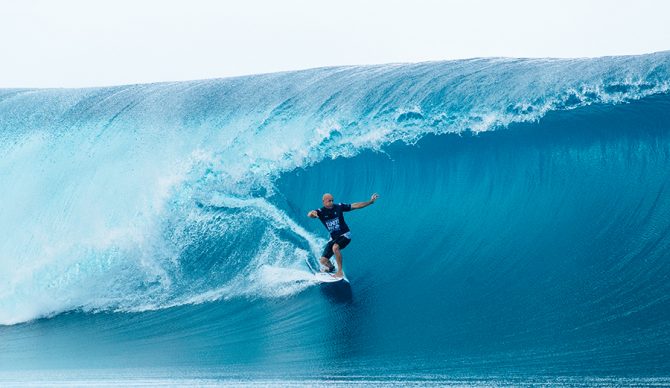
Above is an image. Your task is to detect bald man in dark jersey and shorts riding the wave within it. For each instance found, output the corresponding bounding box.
[307,193,379,278]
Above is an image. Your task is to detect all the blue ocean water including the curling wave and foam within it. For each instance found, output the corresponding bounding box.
[0,52,670,386]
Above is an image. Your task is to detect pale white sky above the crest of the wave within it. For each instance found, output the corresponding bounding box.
[0,0,670,88]
